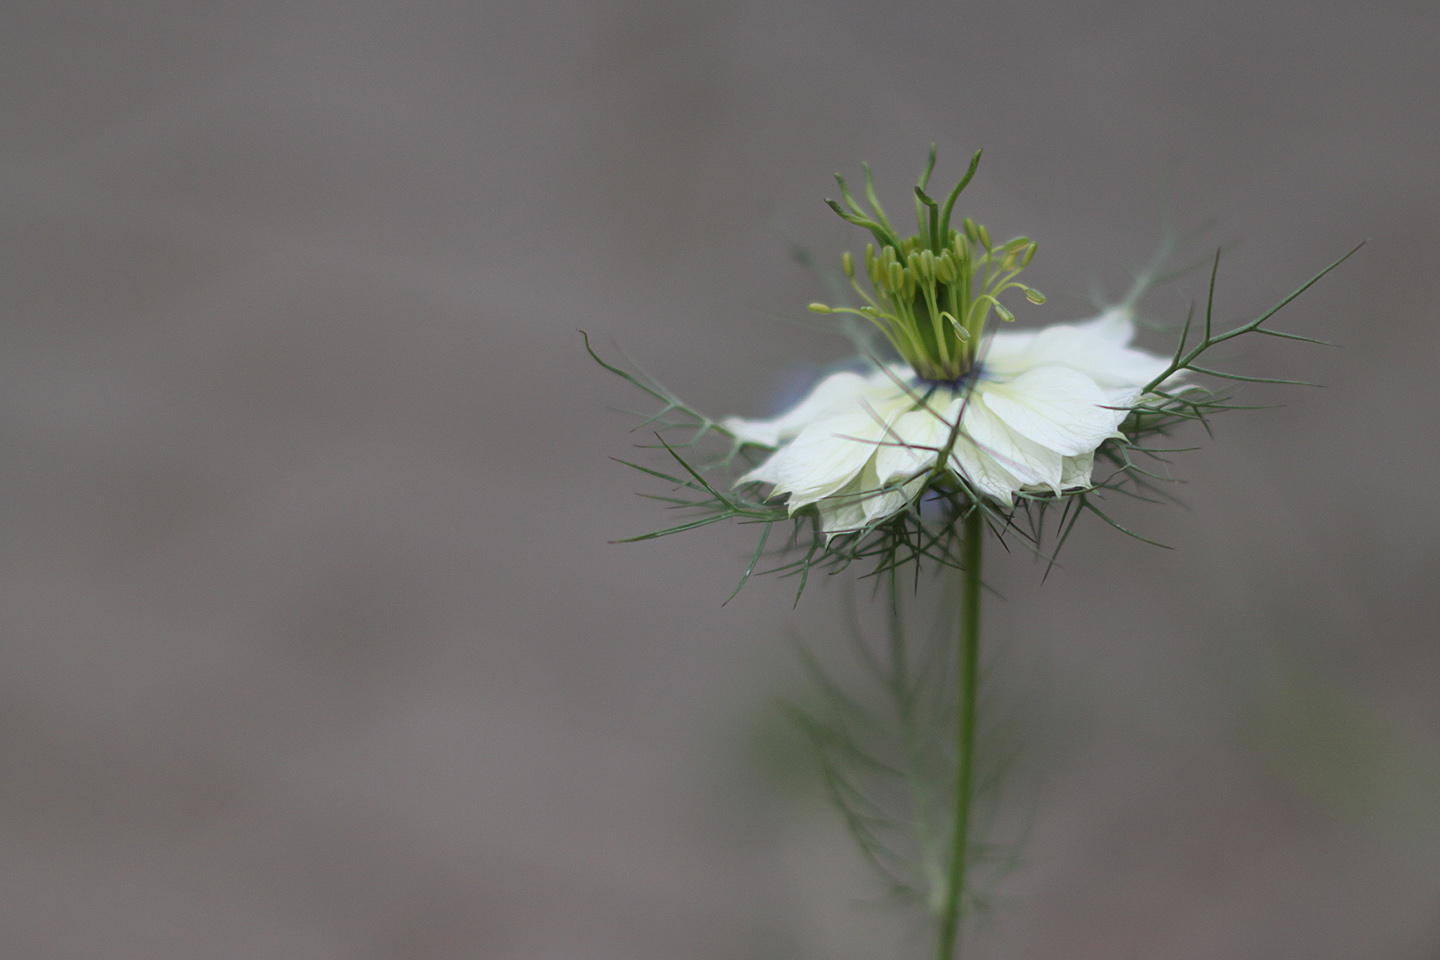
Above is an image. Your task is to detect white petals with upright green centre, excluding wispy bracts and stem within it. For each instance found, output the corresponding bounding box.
[723,148,1168,534]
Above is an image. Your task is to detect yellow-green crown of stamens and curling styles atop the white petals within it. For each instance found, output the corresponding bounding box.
[809,144,1045,380]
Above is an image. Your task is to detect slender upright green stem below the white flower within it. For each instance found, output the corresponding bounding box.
[937,508,985,960]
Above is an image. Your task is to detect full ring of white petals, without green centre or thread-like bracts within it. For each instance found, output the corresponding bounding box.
[724,308,1168,534]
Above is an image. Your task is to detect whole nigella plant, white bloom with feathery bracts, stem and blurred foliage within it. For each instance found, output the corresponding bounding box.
[585,147,1358,960]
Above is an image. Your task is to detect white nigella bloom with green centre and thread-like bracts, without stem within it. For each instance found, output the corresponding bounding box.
[586,147,1358,575]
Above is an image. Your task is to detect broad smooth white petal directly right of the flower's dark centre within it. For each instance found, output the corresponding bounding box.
[975,367,1125,457]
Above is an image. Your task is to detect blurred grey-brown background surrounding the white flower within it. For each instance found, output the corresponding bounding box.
[0,0,1440,960]
